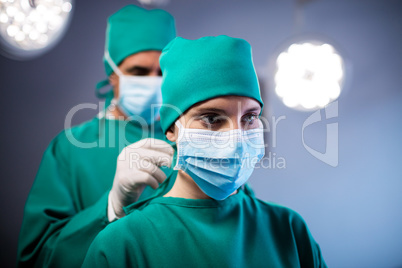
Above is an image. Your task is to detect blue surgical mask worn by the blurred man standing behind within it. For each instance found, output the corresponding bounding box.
[105,52,162,124]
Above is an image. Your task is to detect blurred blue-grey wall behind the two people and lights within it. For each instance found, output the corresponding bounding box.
[0,0,402,267]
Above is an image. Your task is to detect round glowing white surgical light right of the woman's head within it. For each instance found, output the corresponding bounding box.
[274,41,345,111]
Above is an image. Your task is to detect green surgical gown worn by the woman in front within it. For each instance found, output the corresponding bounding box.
[83,173,327,268]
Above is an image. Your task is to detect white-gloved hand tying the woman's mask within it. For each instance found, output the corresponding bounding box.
[108,138,174,221]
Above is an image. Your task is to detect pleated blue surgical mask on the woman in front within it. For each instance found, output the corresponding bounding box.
[174,121,265,200]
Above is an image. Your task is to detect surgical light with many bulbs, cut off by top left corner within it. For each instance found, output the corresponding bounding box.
[0,0,73,59]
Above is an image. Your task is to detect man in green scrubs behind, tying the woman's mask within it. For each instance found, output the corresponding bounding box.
[17,5,176,267]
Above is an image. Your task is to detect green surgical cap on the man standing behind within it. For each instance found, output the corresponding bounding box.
[103,5,176,76]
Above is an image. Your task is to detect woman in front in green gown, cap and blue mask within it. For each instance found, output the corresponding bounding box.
[83,36,326,268]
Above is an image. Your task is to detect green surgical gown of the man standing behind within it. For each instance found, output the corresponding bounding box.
[17,118,173,267]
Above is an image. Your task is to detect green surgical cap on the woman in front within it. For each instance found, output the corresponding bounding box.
[160,35,263,133]
